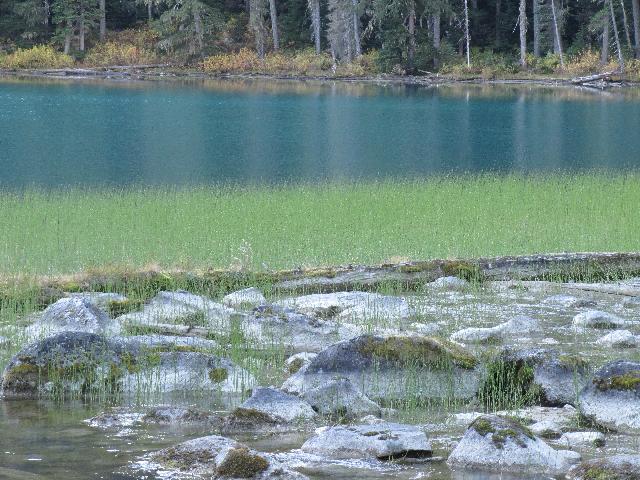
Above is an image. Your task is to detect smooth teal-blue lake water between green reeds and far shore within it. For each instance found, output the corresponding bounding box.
[0,79,640,189]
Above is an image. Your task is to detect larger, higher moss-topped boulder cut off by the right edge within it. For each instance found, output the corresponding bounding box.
[580,360,640,433]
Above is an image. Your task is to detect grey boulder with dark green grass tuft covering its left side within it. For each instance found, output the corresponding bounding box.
[479,349,590,408]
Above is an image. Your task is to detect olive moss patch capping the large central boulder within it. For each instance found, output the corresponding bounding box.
[358,336,478,369]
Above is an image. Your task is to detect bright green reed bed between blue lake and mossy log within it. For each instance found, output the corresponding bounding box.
[0,173,640,276]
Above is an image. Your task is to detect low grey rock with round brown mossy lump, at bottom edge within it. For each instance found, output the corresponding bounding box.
[149,435,306,480]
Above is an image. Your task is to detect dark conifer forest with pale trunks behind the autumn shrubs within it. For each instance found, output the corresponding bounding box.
[0,0,640,72]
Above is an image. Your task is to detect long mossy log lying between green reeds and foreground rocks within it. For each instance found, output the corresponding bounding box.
[10,253,640,294]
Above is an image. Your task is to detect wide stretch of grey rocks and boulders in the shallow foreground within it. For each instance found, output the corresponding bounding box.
[0,260,640,480]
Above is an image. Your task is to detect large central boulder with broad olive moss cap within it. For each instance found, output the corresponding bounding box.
[282,335,480,400]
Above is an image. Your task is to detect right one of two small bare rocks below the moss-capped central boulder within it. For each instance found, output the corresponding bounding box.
[302,378,381,420]
